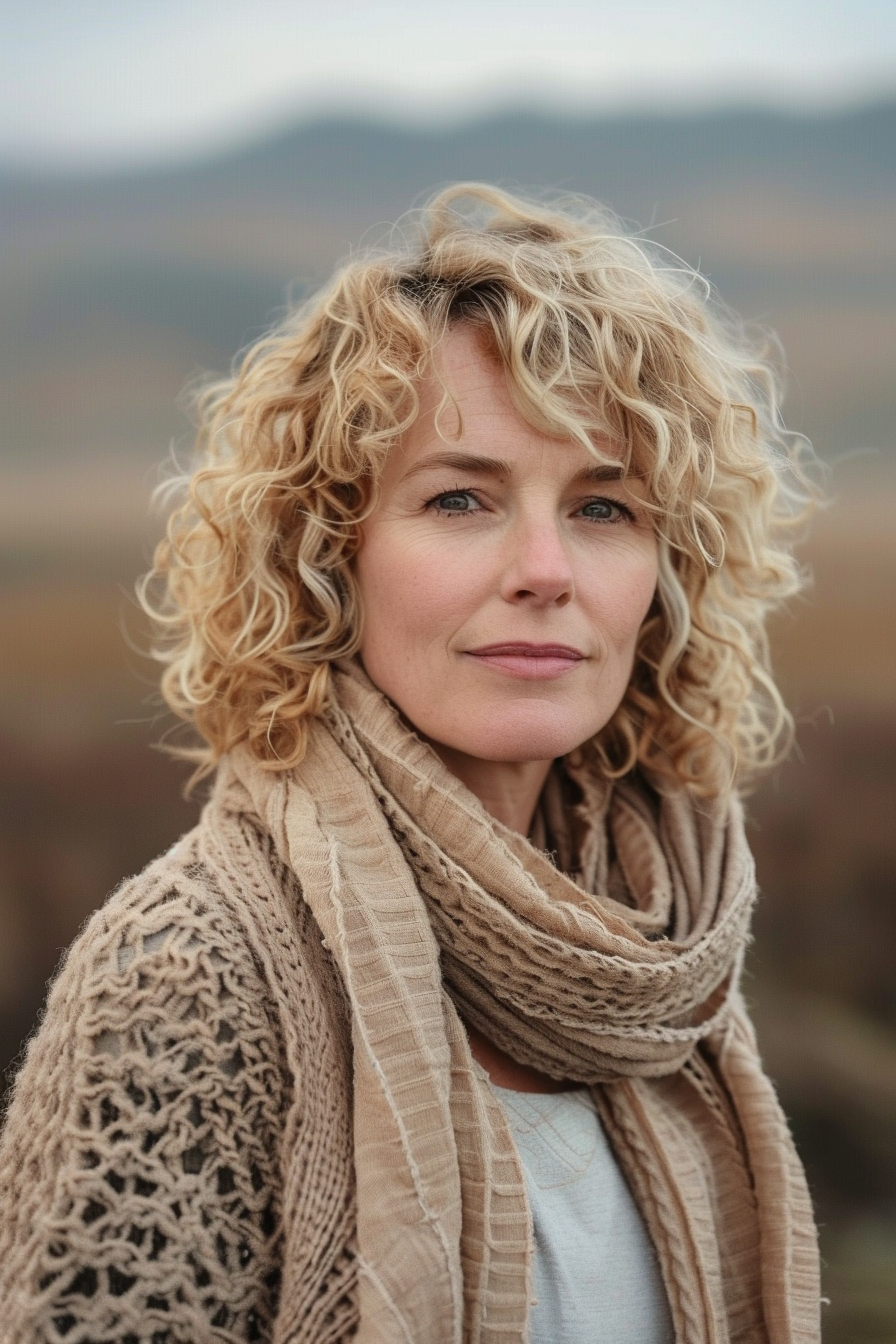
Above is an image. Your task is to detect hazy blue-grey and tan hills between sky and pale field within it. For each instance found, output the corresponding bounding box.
[0,101,896,458]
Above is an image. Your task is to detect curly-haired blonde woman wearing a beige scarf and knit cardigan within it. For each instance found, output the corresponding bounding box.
[0,187,818,1344]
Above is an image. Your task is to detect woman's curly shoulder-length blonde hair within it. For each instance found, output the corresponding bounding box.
[140,184,813,796]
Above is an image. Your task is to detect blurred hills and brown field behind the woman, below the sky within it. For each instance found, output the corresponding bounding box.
[0,105,896,1344]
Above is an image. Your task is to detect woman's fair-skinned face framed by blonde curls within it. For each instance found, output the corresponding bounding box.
[356,325,657,763]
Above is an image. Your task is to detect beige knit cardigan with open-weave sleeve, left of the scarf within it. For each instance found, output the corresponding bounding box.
[0,821,357,1344]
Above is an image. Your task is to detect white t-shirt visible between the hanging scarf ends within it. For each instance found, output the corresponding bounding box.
[492,1083,674,1344]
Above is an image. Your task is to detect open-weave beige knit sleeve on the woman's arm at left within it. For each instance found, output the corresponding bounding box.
[0,857,286,1344]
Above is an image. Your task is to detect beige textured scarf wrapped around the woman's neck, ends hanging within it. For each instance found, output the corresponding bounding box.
[220,668,819,1344]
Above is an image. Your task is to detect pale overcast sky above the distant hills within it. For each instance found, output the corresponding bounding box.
[7,0,896,161]
